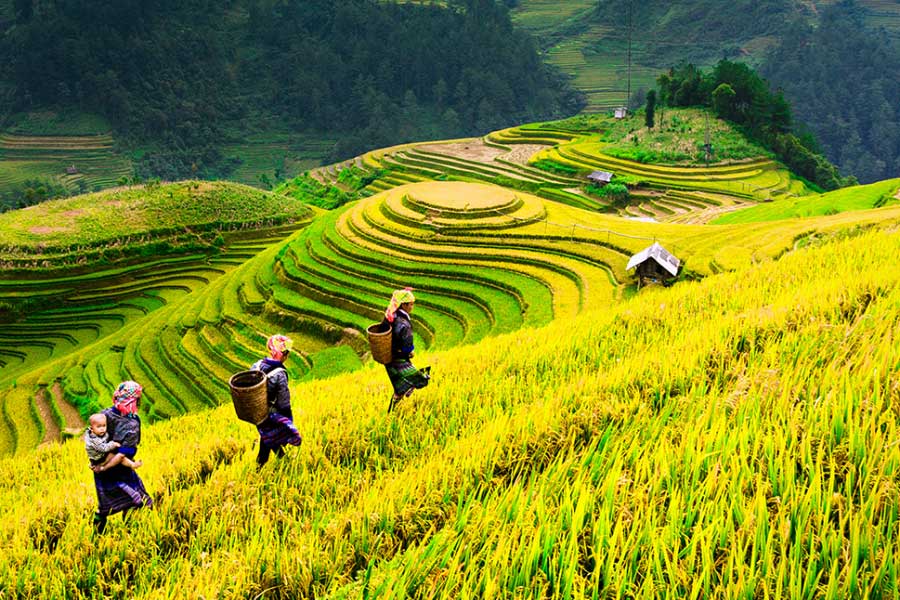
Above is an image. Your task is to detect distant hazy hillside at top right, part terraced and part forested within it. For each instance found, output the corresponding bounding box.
[512,0,900,183]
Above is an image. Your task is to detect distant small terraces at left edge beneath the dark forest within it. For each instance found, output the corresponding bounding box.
[0,133,132,191]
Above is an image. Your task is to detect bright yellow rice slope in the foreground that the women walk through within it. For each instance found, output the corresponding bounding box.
[0,224,900,598]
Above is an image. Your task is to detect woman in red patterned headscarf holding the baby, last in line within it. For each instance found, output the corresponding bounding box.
[92,381,153,533]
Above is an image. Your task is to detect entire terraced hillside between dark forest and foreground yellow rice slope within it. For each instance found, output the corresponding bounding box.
[0,111,900,452]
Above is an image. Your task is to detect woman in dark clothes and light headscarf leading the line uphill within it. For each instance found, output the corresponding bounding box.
[381,288,431,412]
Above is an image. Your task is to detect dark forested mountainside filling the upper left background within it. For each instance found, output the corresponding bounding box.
[0,0,580,178]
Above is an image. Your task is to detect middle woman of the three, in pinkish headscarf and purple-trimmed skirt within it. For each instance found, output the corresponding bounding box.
[250,334,303,469]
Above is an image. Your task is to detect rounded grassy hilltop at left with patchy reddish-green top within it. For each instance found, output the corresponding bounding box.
[0,181,310,270]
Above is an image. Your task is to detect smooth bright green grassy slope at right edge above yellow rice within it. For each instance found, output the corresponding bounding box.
[713,179,900,225]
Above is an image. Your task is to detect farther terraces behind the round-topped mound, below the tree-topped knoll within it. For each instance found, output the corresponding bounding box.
[342,114,809,223]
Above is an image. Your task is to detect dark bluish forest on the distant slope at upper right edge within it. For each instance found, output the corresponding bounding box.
[761,2,900,183]
